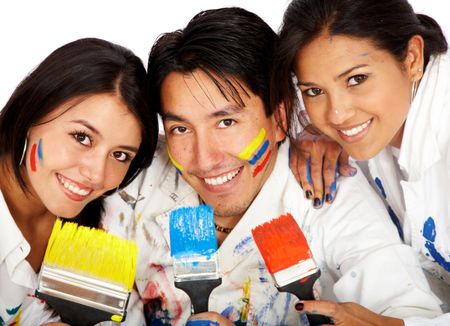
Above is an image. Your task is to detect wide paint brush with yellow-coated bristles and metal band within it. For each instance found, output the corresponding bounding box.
[36,219,137,326]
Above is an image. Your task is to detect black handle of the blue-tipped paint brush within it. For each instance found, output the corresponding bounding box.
[175,278,222,314]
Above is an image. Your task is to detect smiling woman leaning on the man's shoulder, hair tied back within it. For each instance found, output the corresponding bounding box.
[271,0,450,325]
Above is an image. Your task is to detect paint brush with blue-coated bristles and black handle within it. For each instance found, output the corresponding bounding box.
[170,205,222,313]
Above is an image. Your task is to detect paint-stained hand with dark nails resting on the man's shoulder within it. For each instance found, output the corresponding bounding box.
[289,130,357,208]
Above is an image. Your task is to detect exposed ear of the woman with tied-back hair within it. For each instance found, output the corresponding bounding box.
[403,35,424,81]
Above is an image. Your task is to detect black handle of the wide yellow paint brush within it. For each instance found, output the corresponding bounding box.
[35,291,126,326]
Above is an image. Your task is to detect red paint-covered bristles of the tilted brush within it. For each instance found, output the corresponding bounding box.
[252,213,312,274]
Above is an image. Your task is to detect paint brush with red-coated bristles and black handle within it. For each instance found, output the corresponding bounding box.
[252,213,333,325]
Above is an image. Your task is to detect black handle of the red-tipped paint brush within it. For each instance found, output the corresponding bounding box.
[278,269,334,326]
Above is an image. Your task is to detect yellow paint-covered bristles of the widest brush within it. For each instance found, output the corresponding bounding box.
[44,219,137,291]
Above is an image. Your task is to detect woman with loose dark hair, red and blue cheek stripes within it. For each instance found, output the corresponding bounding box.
[0,39,158,325]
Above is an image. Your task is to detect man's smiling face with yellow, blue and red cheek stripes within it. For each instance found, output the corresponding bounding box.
[161,70,285,243]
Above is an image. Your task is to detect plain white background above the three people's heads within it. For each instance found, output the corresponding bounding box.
[0,0,450,109]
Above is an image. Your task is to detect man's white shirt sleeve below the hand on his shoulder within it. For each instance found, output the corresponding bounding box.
[324,174,442,319]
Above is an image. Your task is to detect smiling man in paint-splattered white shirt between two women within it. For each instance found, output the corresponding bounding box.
[104,8,440,325]
